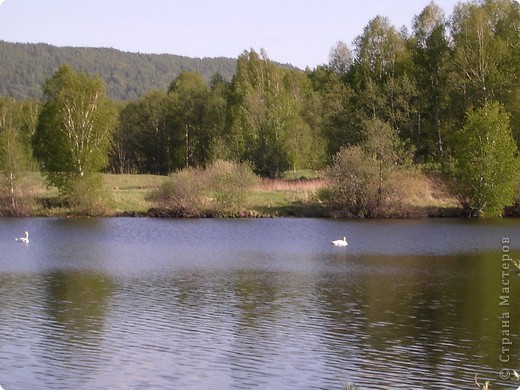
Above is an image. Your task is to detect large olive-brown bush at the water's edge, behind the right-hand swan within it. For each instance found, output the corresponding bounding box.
[321,120,416,218]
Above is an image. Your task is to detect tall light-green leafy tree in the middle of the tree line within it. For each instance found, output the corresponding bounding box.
[230,50,323,177]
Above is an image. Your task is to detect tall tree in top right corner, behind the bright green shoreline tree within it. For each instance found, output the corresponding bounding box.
[448,0,520,133]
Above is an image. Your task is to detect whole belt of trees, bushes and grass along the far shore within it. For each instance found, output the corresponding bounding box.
[0,0,520,218]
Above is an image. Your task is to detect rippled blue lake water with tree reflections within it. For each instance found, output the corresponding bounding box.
[0,218,520,390]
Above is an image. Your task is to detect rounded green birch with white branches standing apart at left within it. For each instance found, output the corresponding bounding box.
[33,65,116,201]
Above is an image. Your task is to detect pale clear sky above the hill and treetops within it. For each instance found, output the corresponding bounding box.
[0,0,464,68]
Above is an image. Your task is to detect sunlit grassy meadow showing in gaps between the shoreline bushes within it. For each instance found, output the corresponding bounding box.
[17,171,460,218]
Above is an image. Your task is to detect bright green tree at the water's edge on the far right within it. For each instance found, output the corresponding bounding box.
[445,101,519,217]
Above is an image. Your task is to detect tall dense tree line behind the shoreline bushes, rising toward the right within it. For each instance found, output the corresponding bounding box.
[111,0,520,171]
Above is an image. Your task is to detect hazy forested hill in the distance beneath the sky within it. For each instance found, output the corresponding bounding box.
[0,40,236,100]
